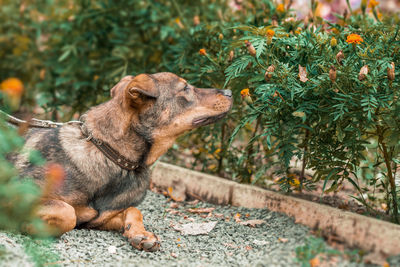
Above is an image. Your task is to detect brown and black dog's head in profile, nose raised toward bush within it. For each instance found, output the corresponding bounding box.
[111,72,232,165]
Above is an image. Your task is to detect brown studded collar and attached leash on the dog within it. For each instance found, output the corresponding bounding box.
[0,110,139,171]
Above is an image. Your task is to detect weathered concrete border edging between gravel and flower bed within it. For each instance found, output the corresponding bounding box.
[152,162,400,257]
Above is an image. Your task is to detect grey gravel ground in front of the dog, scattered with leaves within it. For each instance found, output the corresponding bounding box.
[0,191,386,266]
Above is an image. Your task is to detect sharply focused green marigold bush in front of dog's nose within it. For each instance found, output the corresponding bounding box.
[226,11,400,222]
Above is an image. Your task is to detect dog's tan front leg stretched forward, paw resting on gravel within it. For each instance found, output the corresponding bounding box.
[89,207,160,252]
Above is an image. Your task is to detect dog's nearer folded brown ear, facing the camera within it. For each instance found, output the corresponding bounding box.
[126,74,160,107]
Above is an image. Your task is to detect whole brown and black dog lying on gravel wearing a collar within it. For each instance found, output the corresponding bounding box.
[13,72,233,251]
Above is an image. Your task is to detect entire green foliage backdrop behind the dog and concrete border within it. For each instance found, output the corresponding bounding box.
[0,0,400,221]
